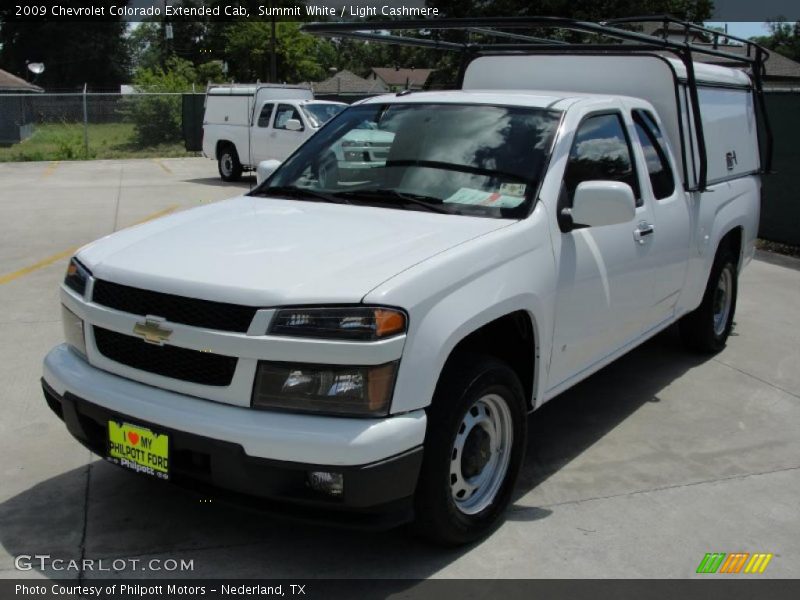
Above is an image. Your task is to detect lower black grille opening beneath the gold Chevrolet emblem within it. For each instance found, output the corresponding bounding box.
[93,327,237,386]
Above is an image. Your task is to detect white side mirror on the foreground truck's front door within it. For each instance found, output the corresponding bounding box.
[571,181,636,227]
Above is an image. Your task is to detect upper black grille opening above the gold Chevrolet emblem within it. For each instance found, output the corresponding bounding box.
[92,279,258,333]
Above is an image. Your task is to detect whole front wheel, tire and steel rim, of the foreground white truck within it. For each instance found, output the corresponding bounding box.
[415,357,527,545]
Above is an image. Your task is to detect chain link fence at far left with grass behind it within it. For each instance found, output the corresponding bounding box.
[0,92,196,161]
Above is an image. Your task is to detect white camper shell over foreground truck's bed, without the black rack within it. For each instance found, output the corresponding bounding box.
[462,55,760,188]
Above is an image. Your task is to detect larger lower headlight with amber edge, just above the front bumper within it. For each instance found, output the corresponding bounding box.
[253,361,397,417]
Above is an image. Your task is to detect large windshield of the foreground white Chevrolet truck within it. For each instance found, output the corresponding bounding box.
[253,103,561,218]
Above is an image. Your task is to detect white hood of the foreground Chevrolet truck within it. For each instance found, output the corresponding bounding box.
[78,196,512,307]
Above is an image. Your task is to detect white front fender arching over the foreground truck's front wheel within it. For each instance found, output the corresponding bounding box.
[364,205,556,413]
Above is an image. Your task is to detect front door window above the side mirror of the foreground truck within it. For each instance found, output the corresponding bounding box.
[564,114,642,206]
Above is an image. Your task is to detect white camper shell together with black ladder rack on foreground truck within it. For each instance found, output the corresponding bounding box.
[304,16,772,191]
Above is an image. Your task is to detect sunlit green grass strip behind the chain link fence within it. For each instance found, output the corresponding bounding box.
[0,123,198,162]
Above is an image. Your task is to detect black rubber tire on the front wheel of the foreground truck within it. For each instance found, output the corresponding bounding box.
[414,356,527,546]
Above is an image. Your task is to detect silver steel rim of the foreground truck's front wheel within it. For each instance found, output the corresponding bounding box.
[450,394,514,515]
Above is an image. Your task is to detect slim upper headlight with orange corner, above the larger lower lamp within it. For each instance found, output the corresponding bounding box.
[269,306,407,341]
